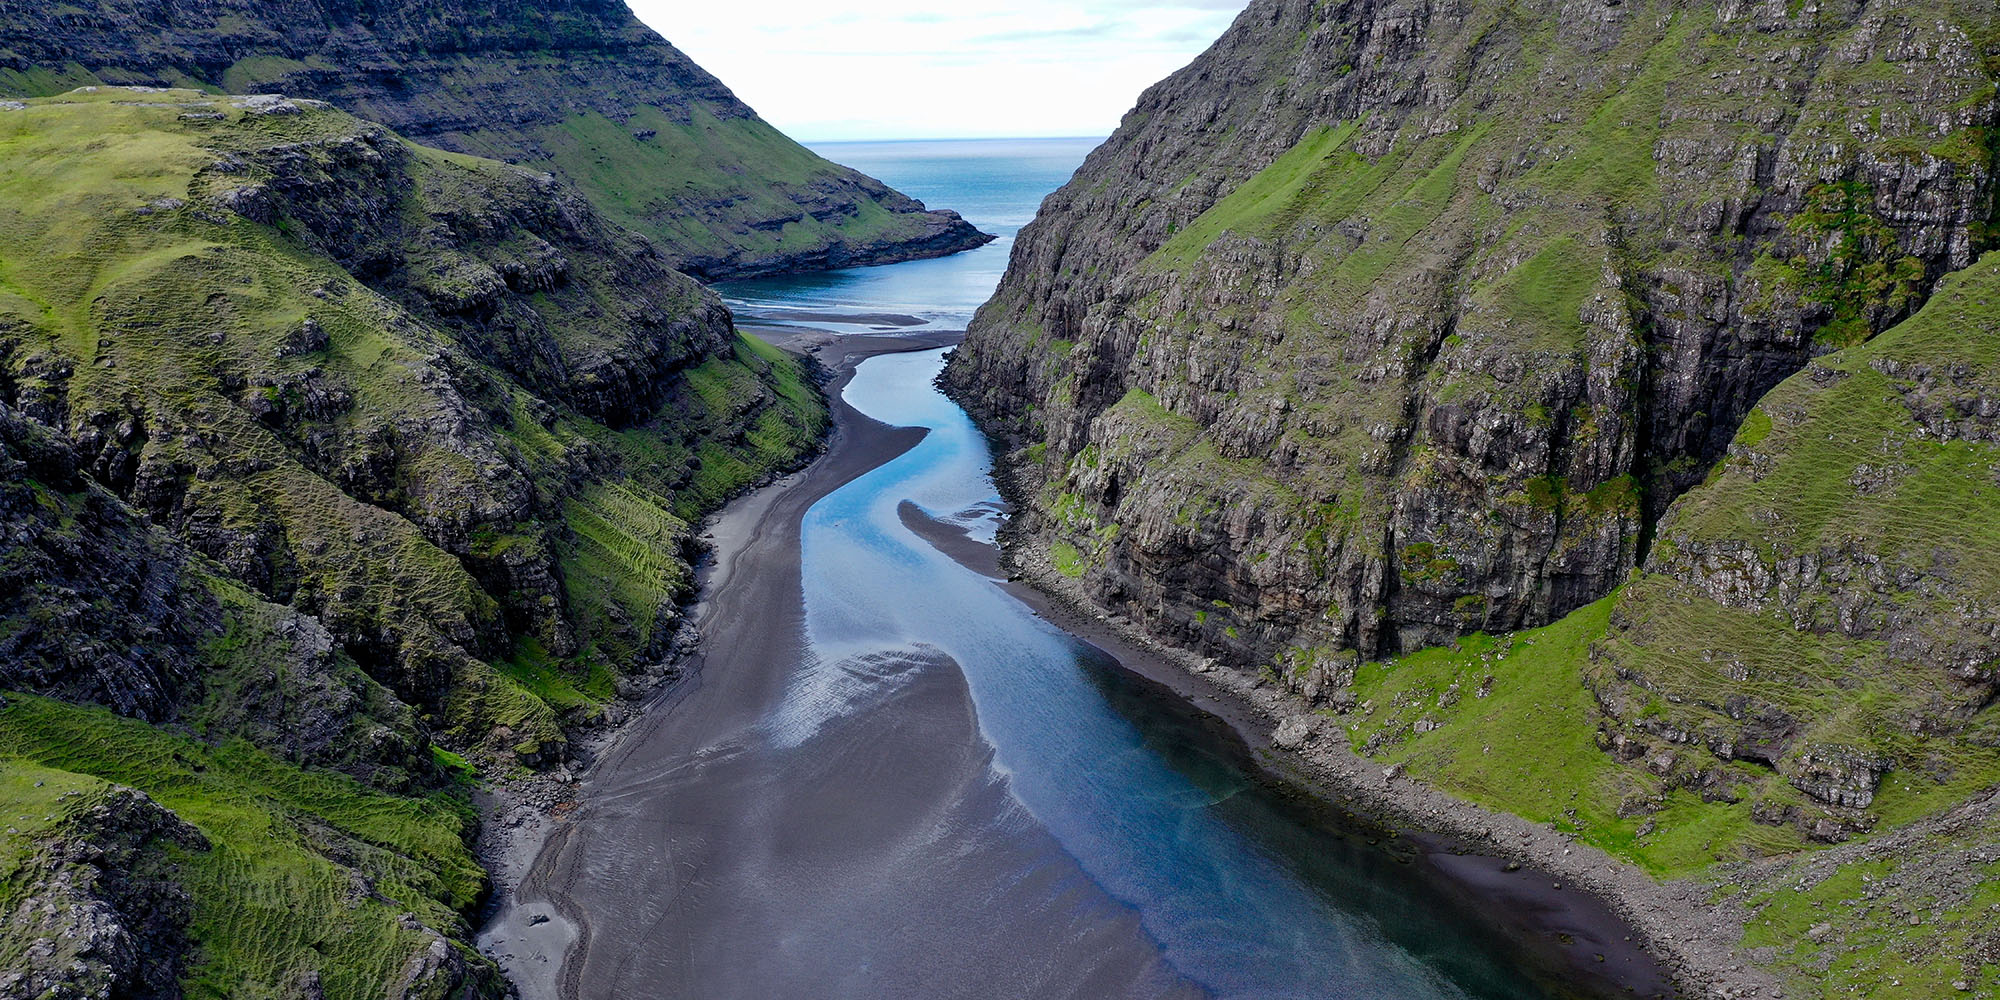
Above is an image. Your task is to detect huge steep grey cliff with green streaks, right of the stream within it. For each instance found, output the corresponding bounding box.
[948,0,1996,688]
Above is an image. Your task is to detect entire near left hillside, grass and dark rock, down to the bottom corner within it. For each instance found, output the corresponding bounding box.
[0,88,824,998]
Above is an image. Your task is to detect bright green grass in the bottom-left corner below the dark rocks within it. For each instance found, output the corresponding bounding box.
[0,694,492,1000]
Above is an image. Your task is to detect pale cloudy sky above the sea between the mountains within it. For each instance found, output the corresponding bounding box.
[628,0,1248,142]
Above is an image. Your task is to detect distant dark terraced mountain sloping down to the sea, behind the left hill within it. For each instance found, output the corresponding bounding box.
[0,0,990,278]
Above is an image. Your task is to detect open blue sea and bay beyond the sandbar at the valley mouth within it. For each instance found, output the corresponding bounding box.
[716,138,1100,332]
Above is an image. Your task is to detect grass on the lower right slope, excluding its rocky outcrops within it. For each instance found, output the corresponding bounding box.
[1344,256,2000,998]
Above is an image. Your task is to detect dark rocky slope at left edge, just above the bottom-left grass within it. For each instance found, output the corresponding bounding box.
[0,404,432,788]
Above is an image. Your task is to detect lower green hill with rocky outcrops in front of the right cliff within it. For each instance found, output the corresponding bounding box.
[1344,254,2000,998]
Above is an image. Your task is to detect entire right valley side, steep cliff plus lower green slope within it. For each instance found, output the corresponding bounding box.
[946,0,2000,998]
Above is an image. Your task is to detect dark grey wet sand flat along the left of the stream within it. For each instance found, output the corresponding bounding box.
[482,332,1200,1000]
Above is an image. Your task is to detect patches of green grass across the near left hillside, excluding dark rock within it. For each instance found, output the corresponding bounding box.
[0,92,824,998]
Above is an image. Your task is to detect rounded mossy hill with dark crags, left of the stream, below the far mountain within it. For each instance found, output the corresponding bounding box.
[0,92,820,758]
